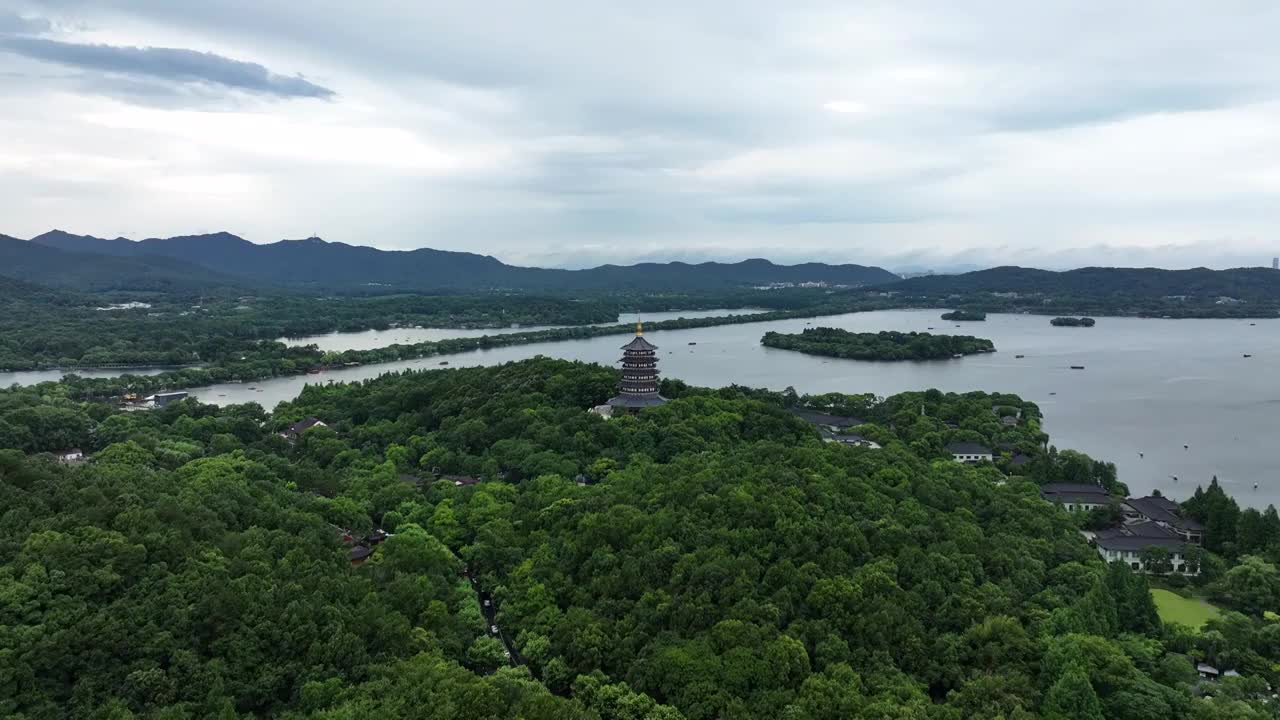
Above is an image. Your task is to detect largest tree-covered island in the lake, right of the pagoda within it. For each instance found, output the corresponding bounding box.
[760,328,996,360]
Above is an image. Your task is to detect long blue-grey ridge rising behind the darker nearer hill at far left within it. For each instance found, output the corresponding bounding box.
[31,231,897,291]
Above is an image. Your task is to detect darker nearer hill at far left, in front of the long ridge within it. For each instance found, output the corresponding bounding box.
[0,234,244,292]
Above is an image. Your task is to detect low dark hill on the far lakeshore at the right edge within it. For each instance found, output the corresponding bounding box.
[892,266,1280,302]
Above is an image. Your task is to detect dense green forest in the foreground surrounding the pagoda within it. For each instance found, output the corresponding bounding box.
[0,359,1280,720]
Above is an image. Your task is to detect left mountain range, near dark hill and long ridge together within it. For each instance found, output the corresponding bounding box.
[15,229,899,291]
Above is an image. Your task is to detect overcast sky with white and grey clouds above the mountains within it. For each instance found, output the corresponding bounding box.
[0,0,1280,268]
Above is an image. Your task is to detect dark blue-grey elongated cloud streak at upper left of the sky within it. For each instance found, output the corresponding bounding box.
[0,36,334,99]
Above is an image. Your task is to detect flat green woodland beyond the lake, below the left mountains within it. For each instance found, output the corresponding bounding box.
[0,285,891,382]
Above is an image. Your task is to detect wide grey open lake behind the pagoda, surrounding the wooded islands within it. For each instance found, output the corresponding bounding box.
[0,310,1280,506]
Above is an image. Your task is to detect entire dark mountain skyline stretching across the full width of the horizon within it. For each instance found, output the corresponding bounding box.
[0,231,1280,298]
